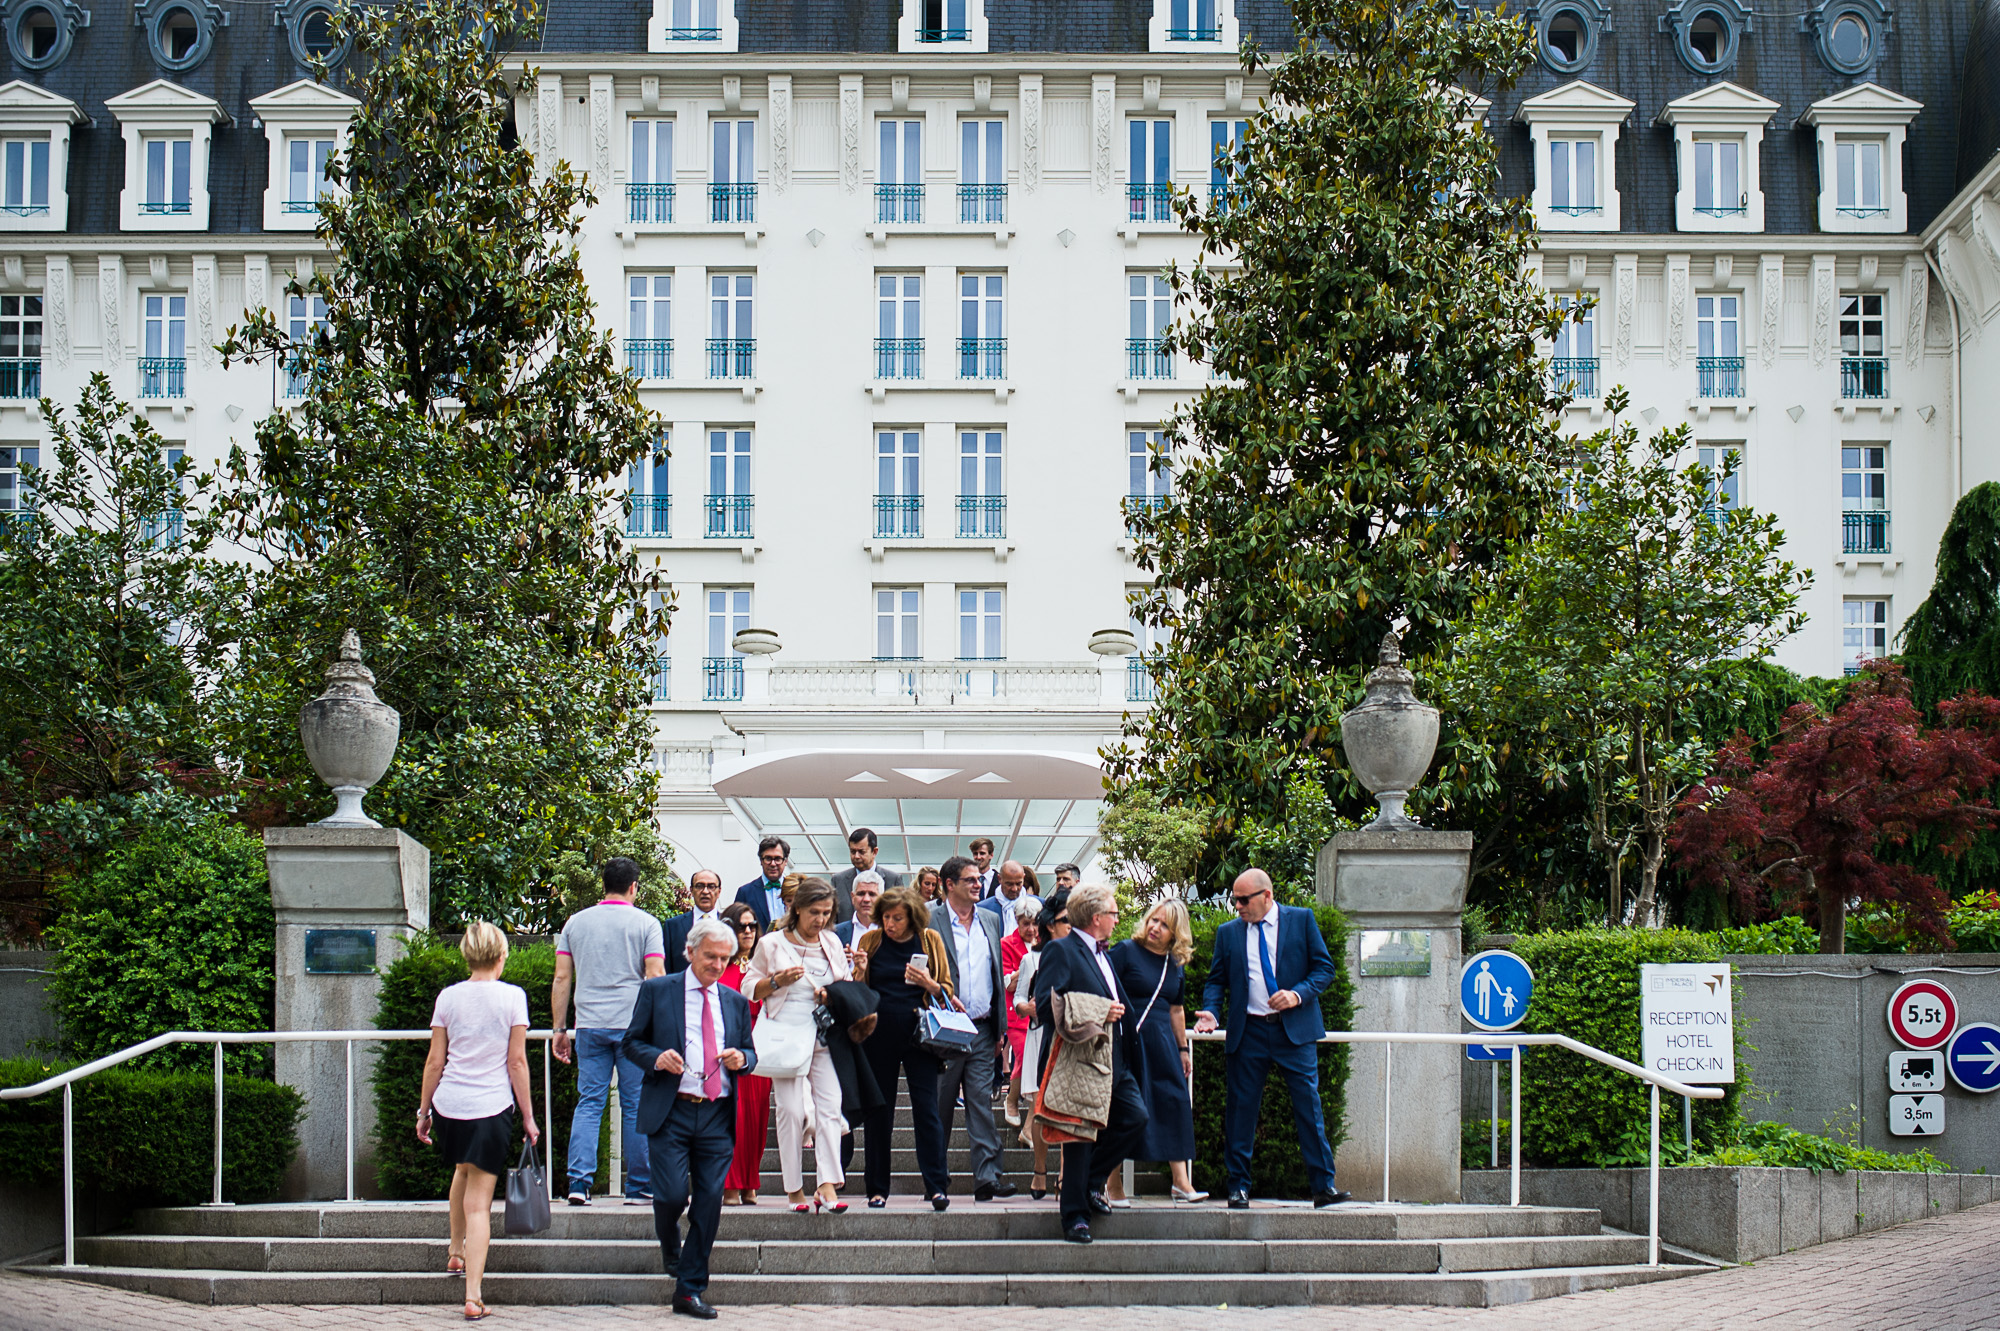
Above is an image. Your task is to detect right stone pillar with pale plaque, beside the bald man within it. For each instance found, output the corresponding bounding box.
[1314,823,1472,1201]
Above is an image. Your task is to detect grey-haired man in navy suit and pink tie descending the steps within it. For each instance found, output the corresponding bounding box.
[624,919,756,1321]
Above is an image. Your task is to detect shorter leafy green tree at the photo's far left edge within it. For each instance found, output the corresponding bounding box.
[0,374,230,939]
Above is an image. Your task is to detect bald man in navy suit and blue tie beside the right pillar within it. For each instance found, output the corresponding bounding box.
[1192,869,1348,1211]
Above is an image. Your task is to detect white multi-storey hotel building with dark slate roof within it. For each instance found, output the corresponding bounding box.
[0,0,2000,883]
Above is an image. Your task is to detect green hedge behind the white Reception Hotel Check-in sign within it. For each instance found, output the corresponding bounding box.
[1514,929,1748,1167]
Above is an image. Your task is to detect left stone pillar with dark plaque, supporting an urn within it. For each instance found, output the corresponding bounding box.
[264,825,430,1201]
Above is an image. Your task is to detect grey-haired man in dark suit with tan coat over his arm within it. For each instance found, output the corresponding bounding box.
[1040,887,1150,1243]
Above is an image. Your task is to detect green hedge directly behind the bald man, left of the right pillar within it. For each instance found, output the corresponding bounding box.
[1182,905,1354,1197]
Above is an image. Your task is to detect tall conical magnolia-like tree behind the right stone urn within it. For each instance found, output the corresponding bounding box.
[1110,0,1562,829]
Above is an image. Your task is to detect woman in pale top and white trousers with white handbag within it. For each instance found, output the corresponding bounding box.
[744,877,854,1215]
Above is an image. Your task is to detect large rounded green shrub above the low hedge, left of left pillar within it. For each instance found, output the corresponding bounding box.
[50,817,274,1075]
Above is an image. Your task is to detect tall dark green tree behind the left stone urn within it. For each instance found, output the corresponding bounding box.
[220,0,664,929]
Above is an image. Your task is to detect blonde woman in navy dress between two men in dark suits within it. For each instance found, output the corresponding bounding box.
[1106,901,1208,1205]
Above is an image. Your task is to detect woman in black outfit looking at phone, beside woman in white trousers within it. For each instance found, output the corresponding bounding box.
[854,887,956,1211]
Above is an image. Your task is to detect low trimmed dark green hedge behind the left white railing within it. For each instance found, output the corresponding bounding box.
[0,1059,304,1207]
